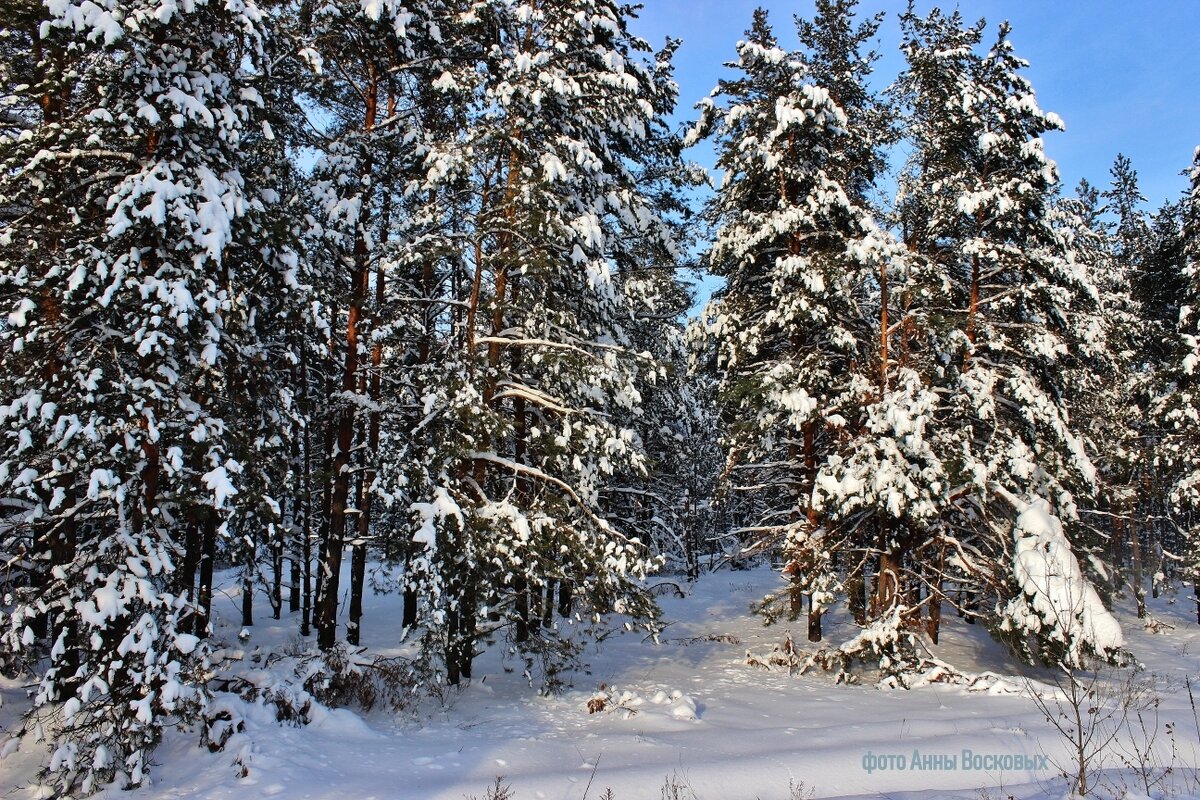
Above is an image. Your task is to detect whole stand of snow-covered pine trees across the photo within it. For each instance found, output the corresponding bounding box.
[0,0,1200,793]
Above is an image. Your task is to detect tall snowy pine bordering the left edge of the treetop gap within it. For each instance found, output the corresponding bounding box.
[690,2,894,640]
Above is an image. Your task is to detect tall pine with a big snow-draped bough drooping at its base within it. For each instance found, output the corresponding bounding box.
[900,7,1122,662]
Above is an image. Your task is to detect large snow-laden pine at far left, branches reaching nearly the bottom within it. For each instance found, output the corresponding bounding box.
[0,0,302,793]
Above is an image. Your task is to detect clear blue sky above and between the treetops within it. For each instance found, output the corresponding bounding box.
[634,0,1200,209]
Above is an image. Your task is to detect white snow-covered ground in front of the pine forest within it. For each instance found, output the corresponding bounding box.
[0,570,1200,800]
